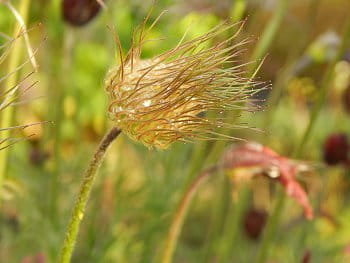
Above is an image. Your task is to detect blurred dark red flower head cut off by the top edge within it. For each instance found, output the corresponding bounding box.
[62,0,101,26]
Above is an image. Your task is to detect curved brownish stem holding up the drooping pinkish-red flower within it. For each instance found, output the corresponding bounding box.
[160,167,216,263]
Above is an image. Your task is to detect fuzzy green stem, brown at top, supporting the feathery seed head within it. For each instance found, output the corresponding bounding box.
[59,127,121,263]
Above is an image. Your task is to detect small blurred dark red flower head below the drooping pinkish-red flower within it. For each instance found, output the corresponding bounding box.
[244,209,267,239]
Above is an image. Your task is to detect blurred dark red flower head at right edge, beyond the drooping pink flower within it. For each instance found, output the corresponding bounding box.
[323,133,349,165]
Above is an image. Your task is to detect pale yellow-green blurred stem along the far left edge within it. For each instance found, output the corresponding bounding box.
[0,0,30,198]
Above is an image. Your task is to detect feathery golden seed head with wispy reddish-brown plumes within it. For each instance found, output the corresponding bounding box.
[105,14,259,149]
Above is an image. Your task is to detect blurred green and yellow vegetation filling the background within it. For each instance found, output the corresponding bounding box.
[0,0,350,263]
